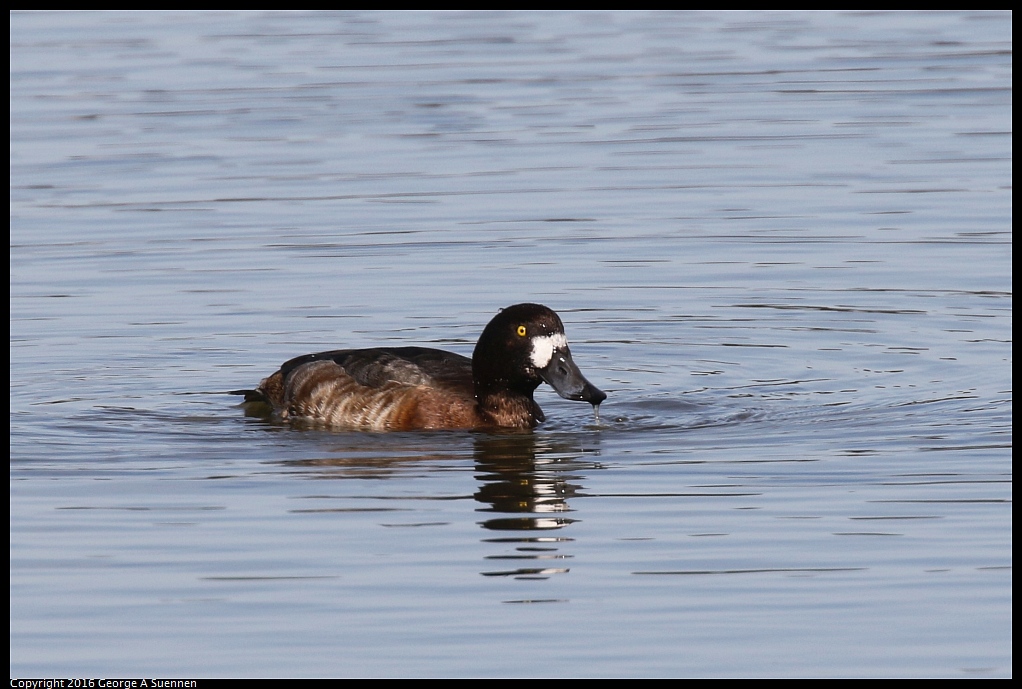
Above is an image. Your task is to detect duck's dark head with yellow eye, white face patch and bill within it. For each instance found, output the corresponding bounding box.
[472,304,607,406]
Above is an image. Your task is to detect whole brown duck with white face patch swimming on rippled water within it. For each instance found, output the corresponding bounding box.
[233,304,607,431]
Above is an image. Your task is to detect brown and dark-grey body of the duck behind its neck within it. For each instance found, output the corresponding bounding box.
[258,347,485,430]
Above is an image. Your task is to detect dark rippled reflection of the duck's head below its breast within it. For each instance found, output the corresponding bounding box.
[475,432,595,579]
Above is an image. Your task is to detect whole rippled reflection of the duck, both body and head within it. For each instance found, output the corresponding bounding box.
[268,424,602,579]
